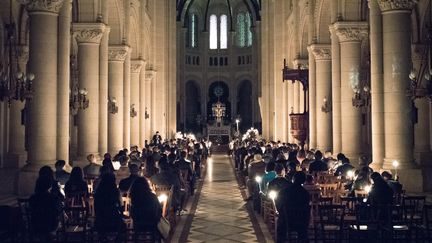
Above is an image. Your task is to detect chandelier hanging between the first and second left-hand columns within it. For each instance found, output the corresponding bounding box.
[69,55,90,115]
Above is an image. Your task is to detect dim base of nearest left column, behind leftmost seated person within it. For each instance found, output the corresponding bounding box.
[16,164,53,197]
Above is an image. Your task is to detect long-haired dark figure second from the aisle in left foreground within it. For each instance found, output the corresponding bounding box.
[94,173,126,232]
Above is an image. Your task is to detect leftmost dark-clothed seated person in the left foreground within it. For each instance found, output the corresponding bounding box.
[29,176,62,235]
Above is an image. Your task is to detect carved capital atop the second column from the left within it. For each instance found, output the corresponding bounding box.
[72,23,105,45]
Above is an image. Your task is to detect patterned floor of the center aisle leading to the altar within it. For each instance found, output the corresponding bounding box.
[187,154,258,243]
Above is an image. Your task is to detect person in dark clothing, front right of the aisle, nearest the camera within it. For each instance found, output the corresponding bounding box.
[276,172,310,243]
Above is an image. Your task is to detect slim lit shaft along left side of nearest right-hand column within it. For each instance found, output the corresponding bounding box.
[369,0,384,170]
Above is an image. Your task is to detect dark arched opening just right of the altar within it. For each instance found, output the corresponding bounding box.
[237,79,253,132]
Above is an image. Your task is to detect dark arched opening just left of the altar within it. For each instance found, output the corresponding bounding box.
[185,80,201,132]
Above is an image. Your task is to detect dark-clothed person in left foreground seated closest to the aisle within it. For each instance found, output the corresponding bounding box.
[130,177,162,233]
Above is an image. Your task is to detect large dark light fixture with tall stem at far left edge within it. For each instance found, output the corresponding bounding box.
[0,0,35,103]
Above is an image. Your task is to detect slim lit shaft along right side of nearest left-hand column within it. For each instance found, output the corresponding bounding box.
[57,0,72,163]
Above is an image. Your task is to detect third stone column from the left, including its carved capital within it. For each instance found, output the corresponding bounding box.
[108,45,129,155]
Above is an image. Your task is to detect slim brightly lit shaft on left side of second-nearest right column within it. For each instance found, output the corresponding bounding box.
[329,25,342,154]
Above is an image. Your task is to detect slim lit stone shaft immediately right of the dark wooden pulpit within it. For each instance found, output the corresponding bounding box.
[308,46,317,148]
